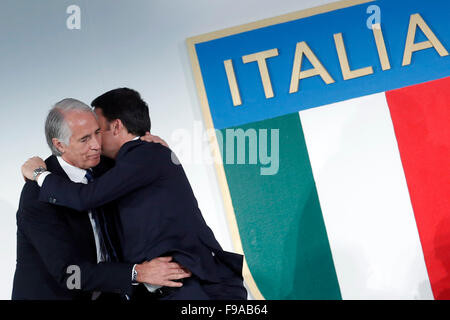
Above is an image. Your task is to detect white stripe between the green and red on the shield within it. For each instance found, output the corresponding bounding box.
[300,93,433,299]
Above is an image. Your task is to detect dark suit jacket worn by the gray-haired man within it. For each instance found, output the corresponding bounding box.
[12,156,133,300]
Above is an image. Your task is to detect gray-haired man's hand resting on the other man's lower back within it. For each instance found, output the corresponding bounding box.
[136,257,192,287]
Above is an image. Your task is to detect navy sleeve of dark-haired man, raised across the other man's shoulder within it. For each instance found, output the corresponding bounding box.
[39,148,162,211]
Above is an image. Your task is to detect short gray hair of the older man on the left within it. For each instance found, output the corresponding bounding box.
[45,98,97,156]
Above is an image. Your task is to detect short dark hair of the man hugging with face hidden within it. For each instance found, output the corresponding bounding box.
[91,88,151,136]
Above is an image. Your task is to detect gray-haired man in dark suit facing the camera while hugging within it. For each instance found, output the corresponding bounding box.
[12,99,189,300]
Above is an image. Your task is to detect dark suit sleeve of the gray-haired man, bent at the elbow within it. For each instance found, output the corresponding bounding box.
[17,182,133,294]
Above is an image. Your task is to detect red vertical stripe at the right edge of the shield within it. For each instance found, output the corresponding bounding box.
[386,77,450,299]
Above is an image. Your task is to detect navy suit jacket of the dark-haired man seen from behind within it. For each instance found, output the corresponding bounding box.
[39,140,246,298]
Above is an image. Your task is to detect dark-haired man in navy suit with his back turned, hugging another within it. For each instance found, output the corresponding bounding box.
[22,88,247,299]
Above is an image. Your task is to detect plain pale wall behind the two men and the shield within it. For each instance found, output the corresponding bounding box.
[0,0,333,299]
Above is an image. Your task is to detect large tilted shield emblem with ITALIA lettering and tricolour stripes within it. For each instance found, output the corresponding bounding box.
[188,0,450,299]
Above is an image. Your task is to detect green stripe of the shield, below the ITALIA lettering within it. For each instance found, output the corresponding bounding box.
[221,113,341,300]
